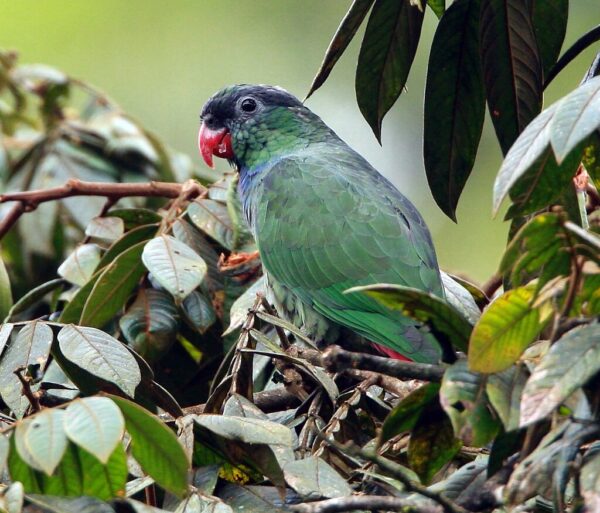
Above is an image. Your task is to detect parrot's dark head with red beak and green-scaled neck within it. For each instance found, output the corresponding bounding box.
[198,84,322,168]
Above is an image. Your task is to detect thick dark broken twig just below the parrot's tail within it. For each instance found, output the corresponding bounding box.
[323,346,445,382]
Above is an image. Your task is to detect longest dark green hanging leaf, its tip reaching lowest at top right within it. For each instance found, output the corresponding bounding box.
[423,0,485,221]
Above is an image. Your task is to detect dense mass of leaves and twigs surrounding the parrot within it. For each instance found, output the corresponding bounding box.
[0,0,600,513]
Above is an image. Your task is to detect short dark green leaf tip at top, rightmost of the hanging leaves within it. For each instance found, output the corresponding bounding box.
[531,0,569,76]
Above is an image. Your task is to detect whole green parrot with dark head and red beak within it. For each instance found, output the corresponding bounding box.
[198,84,444,363]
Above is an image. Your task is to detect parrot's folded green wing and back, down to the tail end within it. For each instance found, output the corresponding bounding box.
[255,151,443,361]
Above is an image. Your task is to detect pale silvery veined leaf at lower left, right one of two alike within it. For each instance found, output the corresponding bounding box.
[58,325,142,397]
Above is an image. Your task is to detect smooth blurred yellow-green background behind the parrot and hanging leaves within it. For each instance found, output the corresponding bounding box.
[0,0,600,282]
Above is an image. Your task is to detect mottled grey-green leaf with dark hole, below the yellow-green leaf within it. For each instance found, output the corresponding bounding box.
[440,360,500,447]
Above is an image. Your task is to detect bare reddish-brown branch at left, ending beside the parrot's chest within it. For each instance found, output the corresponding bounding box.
[0,179,206,239]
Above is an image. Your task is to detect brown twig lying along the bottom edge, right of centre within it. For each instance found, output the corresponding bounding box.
[290,495,443,513]
